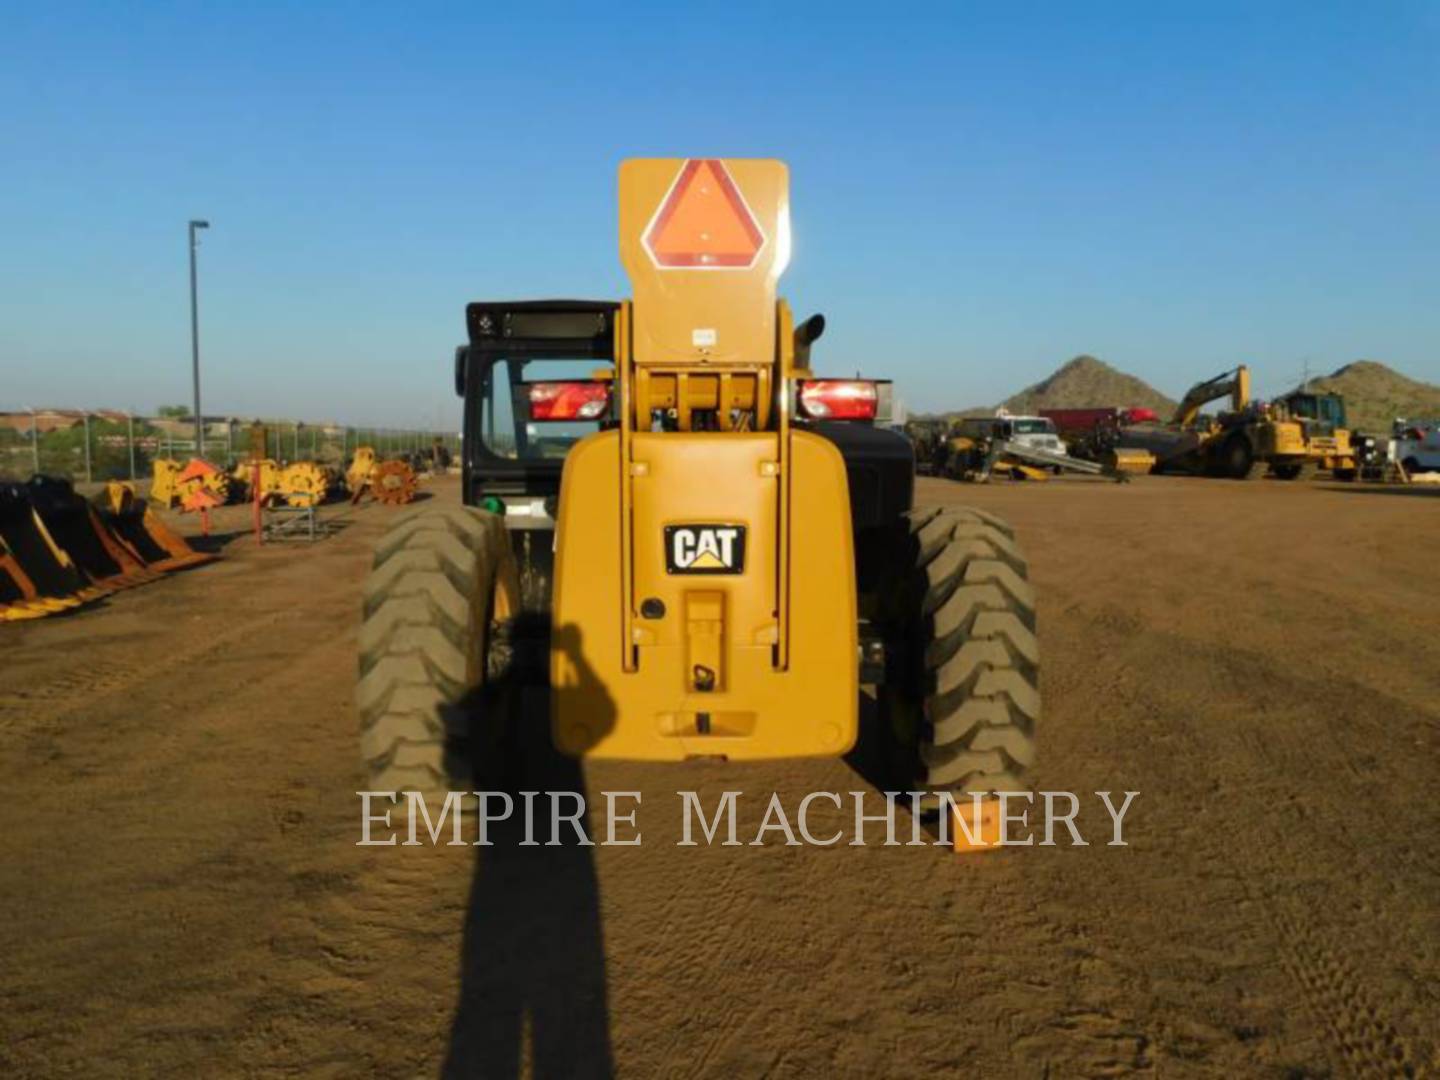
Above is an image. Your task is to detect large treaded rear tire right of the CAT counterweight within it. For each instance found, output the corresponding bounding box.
[880,508,1040,793]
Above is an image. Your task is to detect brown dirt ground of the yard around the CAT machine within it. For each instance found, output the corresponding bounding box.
[0,478,1440,1077]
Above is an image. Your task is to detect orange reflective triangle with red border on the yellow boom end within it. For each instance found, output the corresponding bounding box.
[644,157,765,269]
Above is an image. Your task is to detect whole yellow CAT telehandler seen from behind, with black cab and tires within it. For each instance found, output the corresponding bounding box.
[357,158,1040,823]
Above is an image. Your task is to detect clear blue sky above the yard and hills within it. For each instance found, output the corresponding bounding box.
[0,3,1440,426]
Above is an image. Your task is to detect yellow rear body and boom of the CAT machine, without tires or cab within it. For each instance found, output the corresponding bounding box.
[550,158,858,760]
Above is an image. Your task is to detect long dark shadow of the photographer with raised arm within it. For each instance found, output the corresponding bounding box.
[442,626,615,1077]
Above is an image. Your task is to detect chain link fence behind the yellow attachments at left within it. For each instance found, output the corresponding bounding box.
[0,409,459,484]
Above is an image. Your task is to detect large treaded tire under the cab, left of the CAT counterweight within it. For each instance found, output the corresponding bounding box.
[356,507,513,795]
